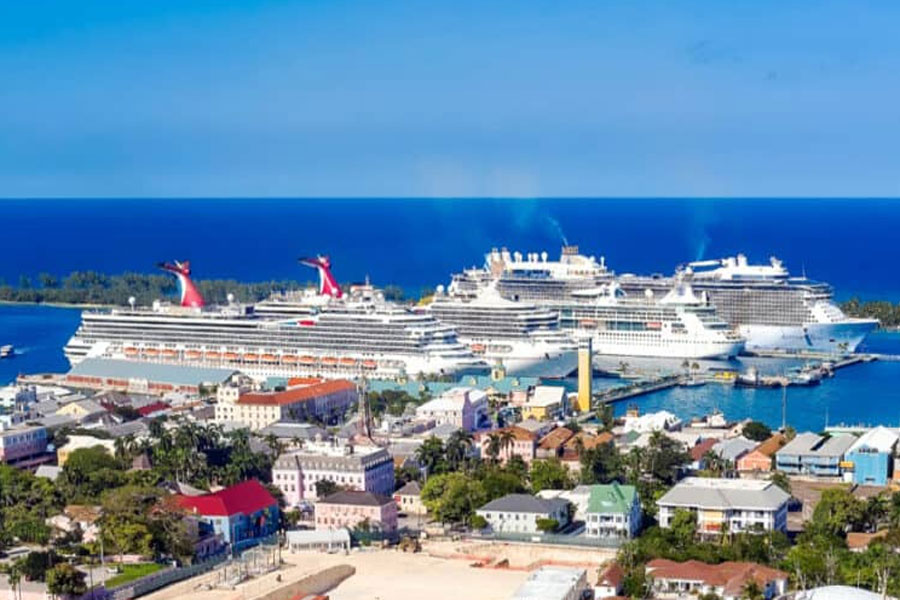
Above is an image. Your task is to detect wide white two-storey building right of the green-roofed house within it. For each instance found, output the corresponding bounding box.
[656,477,790,534]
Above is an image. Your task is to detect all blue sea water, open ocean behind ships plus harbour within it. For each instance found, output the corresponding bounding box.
[0,199,900,430]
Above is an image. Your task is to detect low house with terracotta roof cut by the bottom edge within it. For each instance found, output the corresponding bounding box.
[646,558,788,600]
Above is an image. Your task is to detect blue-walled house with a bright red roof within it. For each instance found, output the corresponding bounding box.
[174,479,279,548]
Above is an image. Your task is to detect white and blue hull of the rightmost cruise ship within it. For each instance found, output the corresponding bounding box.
[739,319,878,354]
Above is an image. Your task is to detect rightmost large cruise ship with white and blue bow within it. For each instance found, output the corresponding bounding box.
[619,254,878,353]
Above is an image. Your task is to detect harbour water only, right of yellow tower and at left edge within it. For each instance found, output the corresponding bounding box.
[0,305,900,430]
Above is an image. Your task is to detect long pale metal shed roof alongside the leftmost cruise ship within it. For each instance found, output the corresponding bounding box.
[69,358,237,385]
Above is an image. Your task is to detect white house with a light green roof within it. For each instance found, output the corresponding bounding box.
[585,483,641,539]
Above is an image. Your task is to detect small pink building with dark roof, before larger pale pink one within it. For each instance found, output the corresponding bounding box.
[316,491,397,533]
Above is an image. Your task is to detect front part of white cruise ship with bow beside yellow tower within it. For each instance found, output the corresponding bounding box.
[428,285,578,377]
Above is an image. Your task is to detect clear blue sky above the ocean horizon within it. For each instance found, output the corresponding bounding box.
[0,0,900,197]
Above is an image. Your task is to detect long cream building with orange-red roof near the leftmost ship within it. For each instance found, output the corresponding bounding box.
[215,379,358,431]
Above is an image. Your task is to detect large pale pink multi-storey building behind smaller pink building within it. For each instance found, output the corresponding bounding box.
[272,440,394,507]
